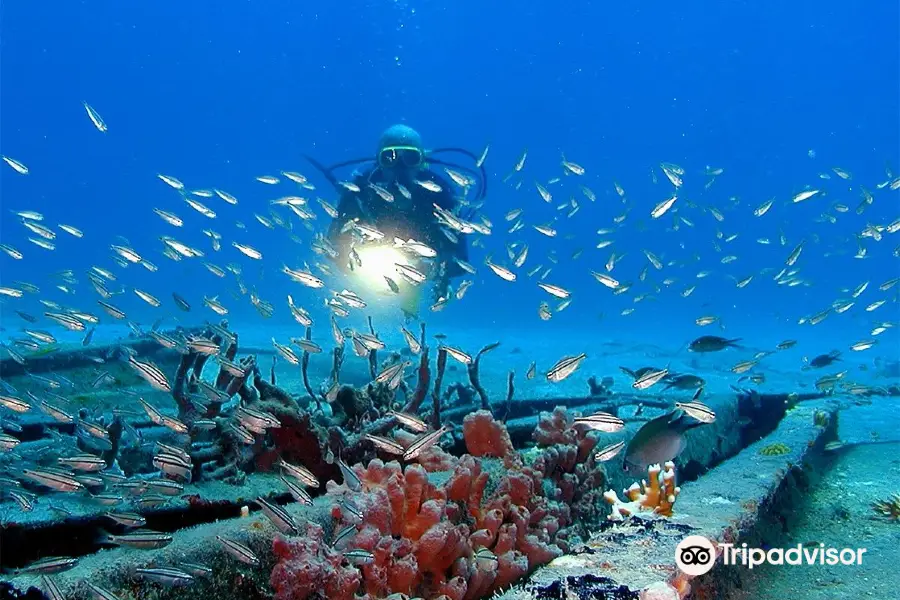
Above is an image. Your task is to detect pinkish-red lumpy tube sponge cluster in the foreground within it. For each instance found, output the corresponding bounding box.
[271,409,620,600]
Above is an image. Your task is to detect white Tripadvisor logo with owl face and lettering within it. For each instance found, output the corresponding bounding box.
[675,535,866,577]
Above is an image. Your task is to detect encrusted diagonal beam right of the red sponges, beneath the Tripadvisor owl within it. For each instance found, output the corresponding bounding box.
[501,402,837,600]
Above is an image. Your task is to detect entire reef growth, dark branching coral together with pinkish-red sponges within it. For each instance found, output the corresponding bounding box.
[0,314,676,600]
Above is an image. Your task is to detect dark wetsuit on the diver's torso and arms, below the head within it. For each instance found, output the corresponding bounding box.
[328,163,469,294]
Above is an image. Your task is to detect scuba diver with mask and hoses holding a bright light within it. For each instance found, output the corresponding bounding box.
[306,125,487,314]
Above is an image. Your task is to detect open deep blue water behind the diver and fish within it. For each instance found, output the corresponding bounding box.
[0,0,900,352]
